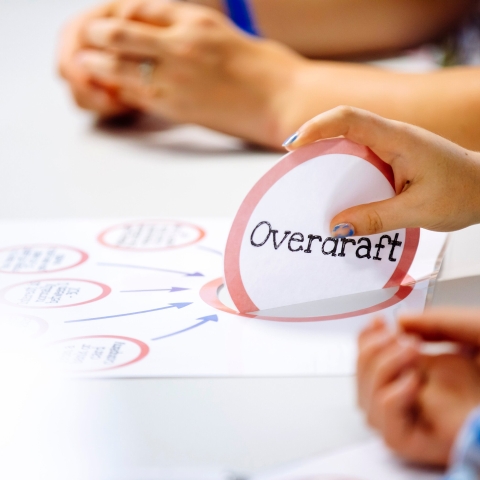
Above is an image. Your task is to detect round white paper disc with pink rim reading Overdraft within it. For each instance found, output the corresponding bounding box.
[225,139,420,313]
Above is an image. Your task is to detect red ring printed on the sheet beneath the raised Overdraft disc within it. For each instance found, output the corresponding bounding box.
[199,278,414,322]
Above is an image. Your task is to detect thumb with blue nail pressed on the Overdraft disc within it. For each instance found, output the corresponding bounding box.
[330,193,418,238]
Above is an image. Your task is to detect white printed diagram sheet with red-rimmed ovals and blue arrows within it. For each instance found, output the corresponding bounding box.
[0,218,445,377]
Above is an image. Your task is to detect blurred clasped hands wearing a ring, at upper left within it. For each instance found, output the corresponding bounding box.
[60,0,302,148]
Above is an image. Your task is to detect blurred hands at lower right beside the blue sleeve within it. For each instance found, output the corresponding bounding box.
[357,309,480,466]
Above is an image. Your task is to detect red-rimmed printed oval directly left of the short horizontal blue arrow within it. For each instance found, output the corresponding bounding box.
[0,278,111,308]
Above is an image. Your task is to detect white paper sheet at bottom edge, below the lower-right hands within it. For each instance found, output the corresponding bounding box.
[250,439,442,480]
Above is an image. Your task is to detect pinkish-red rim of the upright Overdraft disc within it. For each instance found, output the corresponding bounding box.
[224,138,420,312]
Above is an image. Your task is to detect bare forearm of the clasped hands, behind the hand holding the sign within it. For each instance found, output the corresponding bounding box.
[275,61,480,150]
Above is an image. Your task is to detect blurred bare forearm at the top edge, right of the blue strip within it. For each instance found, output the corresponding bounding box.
[191,0,475,58]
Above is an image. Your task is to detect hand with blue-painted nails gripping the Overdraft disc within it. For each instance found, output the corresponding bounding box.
[284,107,480,237]
